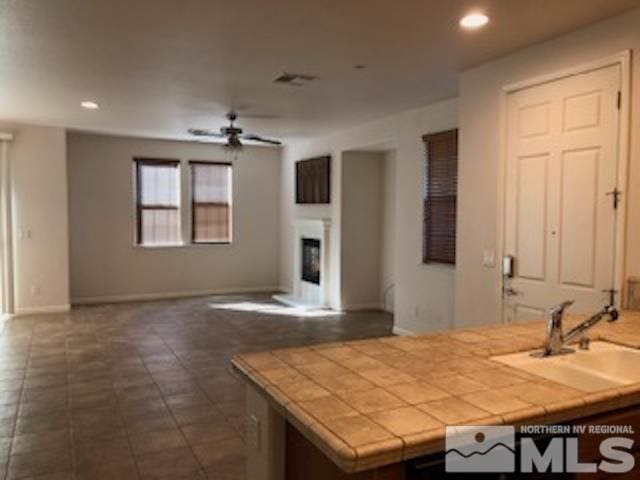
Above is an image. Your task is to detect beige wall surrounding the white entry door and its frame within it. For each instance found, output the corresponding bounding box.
[455,9,640,325]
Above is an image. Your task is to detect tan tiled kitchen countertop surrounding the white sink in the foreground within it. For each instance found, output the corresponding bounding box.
[233,311,640,472]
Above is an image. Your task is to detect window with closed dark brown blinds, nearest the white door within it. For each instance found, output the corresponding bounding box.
[422,130,458,265]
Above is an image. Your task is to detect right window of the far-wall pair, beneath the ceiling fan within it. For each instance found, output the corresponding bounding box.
[190,161,232,243]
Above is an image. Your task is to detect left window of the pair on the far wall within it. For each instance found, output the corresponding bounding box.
[135,158,181,246]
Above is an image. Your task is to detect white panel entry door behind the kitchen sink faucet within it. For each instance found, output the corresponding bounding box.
[504,62,620,321]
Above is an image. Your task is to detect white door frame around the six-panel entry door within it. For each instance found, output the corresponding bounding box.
[496,50,631,323]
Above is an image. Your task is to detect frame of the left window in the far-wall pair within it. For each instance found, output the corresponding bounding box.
[133,157,184,248]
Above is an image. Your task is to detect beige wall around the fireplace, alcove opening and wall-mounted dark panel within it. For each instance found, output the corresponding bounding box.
[280,100,458,332]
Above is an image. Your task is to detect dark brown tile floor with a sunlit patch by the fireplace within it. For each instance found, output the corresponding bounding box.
[0,296,392,480]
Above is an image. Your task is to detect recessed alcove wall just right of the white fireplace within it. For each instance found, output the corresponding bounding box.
[340,152,384,310]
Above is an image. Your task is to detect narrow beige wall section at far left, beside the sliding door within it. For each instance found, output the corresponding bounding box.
[4,126,69,313]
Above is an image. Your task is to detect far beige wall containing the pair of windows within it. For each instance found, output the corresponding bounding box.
[68,133,280,302]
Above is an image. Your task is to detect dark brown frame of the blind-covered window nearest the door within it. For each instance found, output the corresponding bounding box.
[422,128,460,268]
